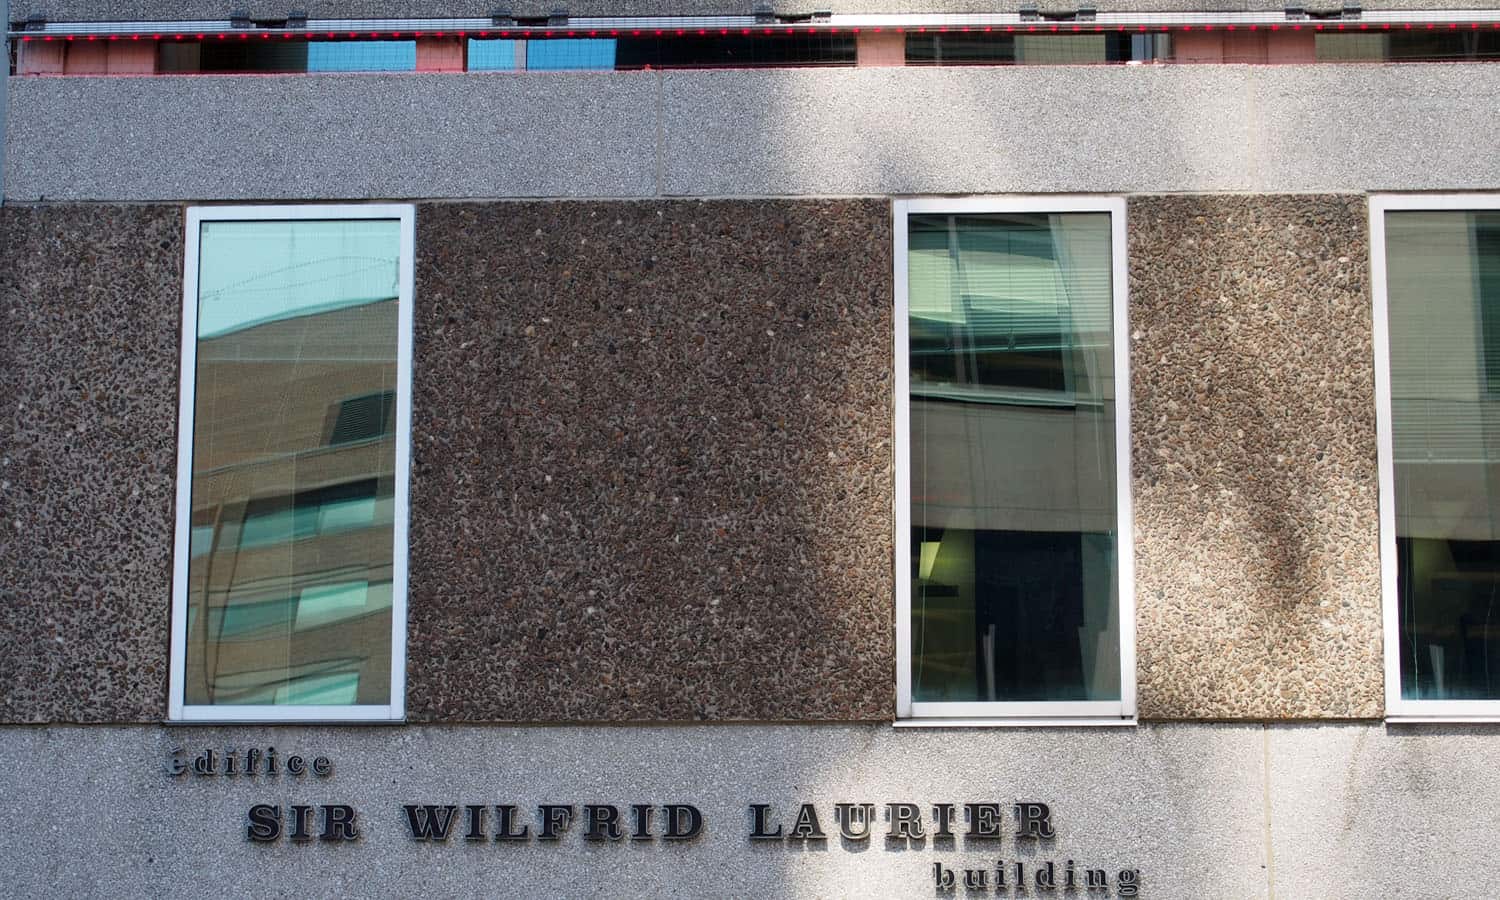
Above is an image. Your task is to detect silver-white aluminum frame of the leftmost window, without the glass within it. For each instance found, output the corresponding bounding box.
[167,204,416,723]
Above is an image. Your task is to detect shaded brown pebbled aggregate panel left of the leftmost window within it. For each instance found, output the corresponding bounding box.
[0,206,183,722]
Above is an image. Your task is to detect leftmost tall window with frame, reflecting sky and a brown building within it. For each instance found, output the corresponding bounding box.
[170,206,413,722]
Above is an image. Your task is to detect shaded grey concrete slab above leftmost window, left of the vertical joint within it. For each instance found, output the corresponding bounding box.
[6,72,657,200]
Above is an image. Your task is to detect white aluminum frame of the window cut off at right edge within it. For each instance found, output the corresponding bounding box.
[1370,194,1500,723]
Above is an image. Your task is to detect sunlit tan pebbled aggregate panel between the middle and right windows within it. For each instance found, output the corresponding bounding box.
[1130,195,1383,719]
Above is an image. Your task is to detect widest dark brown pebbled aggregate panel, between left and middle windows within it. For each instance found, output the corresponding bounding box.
[408,201,894,722]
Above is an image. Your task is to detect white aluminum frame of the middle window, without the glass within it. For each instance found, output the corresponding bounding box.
[891,194,1136,728]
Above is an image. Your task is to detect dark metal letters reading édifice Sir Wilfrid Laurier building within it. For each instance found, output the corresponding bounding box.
[164,747,1140,899]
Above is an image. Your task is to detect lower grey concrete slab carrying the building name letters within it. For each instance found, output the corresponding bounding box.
[0,725,1272,899]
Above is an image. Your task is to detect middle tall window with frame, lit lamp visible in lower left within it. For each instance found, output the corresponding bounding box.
[896,197,1136,722]
